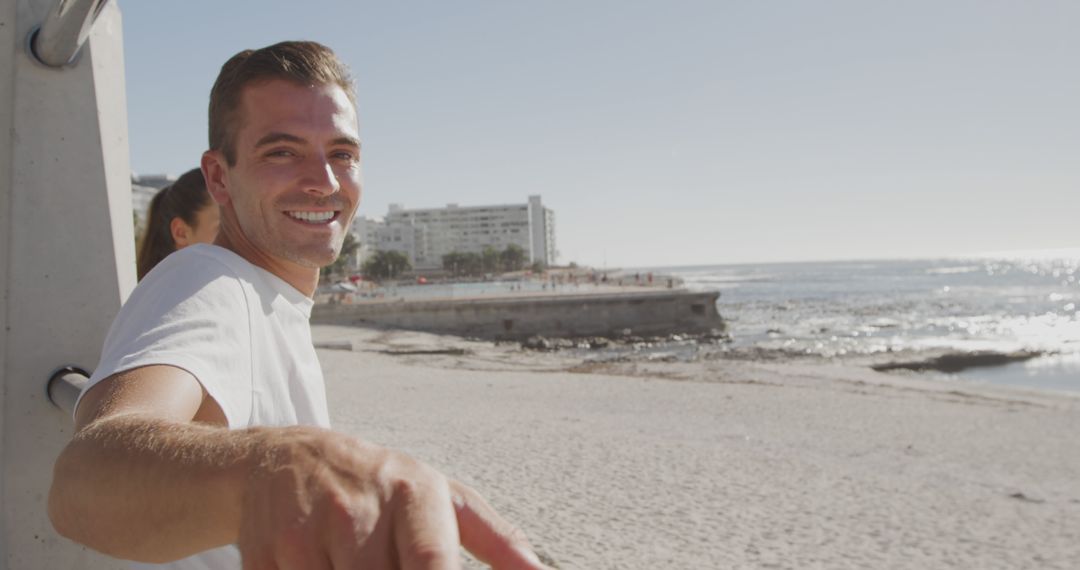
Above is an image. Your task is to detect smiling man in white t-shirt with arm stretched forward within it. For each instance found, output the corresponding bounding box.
[49,42,542,570]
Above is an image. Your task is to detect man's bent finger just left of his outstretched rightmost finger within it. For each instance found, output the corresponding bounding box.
[393,477,461,570]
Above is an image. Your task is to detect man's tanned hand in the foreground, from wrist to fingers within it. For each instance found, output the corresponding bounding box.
[238,428,545,570]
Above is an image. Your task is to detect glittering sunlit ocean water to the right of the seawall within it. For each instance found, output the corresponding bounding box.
[651,250,1080,392]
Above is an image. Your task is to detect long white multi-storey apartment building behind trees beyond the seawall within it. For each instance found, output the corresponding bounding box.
[353,195,557,270]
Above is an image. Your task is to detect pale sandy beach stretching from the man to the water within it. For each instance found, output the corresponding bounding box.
[313,326,1080,569]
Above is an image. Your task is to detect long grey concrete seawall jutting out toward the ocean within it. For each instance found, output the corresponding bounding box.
[311,289,724,339]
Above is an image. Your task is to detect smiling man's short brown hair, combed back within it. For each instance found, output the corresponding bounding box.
[210,41,356,166]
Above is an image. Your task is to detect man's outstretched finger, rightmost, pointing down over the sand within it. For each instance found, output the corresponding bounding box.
[450,480,548,570]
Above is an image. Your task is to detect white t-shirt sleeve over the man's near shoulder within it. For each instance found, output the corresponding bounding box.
[76,258,253,428]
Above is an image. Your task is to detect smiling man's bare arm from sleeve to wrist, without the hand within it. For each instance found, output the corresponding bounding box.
[49,366,247,561]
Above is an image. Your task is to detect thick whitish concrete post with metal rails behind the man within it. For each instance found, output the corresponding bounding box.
[0,0,135,570]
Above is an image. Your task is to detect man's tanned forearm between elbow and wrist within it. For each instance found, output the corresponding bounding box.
[49,415,264,562]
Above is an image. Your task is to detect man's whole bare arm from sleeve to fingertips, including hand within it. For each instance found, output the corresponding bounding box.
[49,366,542,570]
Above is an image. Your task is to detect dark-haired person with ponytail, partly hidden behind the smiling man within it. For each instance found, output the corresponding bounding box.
[135,168,221,281]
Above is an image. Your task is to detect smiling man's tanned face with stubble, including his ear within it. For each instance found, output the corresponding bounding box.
[210,80,361,269]
